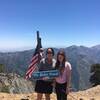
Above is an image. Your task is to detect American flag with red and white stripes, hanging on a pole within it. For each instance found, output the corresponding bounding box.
[25,31,42,79]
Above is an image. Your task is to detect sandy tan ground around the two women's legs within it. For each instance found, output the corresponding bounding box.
[0,85,100,100]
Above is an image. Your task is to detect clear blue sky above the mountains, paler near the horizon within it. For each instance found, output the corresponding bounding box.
[0,0,100,50]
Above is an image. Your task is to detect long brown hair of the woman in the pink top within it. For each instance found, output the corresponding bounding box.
[55,50,66,72]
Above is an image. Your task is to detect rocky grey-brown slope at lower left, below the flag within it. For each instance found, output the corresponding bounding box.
[0,73,34,94]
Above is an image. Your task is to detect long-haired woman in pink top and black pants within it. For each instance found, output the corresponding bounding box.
[55,50,71,100]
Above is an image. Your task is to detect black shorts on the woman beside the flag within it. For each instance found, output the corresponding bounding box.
[35,80,53,94]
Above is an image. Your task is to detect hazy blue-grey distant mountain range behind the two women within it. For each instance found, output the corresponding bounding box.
[0,45,100,90]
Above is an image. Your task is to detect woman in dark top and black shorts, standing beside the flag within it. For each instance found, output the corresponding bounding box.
[35,48,56,100]
